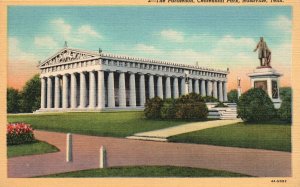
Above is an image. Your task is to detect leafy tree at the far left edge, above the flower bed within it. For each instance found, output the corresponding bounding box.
[7,88,20,113]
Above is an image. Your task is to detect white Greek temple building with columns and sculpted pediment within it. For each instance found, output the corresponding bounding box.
[39,47,228,112]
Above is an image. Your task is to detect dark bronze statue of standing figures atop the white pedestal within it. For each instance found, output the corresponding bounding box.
[253,37,271,67]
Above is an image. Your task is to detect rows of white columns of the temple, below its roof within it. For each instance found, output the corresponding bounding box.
[41,70,227,109]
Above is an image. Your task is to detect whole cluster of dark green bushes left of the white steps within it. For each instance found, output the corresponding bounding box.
[144,93,208,120]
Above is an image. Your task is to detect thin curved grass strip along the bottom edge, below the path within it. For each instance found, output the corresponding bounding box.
[41,166,249,177]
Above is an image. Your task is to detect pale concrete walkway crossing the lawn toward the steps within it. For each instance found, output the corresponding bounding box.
[126,119,242,142]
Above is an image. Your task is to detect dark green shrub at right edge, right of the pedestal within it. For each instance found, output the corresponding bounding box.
[278,95,292,122]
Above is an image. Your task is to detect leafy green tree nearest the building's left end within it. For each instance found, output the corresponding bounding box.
[21,74,41,112]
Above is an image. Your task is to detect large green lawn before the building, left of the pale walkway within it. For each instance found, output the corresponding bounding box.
[8,112,187,137]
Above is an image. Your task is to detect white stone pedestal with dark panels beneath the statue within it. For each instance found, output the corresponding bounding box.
[248,67,282,109]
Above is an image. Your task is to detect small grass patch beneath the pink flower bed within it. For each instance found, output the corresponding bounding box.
[7,141,59,158]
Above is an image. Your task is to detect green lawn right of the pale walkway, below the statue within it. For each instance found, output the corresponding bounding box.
[168,123,291,152]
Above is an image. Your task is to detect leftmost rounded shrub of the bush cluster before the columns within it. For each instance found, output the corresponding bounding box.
[144,97,163,119]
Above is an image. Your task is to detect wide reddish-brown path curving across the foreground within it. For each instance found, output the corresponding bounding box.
[8,130,291,177]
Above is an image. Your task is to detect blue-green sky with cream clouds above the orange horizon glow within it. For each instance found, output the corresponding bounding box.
[8,6,292,90]
